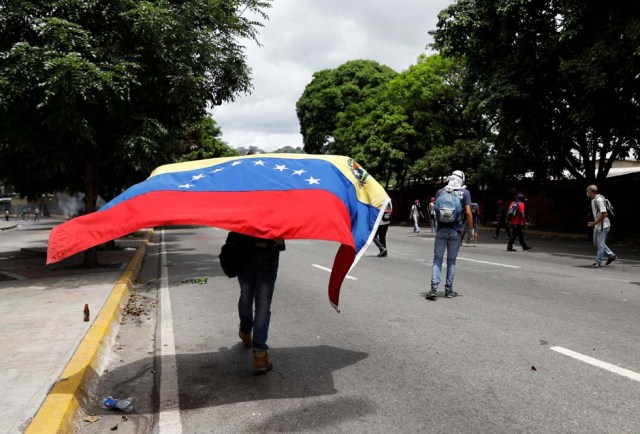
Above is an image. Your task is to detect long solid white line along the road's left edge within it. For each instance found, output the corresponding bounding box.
[158,229,182,434]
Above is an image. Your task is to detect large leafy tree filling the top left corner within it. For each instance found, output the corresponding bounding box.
[0,0,270,264]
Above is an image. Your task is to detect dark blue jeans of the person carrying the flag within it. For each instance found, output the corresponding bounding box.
[238,262,278,351]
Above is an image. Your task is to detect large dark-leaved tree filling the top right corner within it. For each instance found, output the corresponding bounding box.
[433,0,640,180]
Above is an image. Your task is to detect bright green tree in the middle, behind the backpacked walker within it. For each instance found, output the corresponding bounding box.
[331,55,488,185]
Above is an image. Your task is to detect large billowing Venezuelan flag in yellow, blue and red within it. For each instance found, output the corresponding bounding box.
[47,154,389,309]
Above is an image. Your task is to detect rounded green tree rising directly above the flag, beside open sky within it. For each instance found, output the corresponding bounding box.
[296,60,397,154]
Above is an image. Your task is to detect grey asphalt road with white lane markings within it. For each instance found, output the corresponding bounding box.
[81,226,640,433]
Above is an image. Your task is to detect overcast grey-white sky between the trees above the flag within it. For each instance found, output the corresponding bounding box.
[213,0,453,151]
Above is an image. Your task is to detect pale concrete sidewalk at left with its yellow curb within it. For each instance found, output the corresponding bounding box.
[0,218,153,433]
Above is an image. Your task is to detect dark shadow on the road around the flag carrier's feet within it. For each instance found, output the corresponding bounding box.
[84,343,369,416]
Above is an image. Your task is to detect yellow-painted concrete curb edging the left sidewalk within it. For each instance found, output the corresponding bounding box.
[25,229,153,434]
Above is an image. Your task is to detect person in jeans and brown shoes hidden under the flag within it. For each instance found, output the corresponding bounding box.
[226,232,285,374]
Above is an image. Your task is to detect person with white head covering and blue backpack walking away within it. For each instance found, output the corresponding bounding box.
[425,170,473,301]
